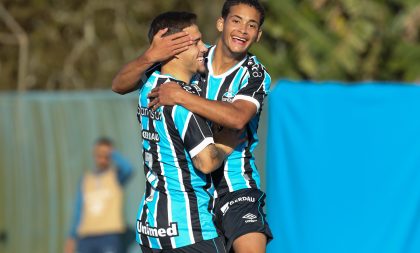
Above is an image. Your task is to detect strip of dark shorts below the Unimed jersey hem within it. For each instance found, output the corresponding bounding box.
[140,237,226,253]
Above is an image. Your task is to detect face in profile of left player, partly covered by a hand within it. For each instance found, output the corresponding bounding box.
[177,25,207,73]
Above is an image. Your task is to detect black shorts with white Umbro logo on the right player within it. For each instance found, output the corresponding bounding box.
[214,189,273,251]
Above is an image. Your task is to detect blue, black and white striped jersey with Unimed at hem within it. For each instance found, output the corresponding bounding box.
[136,71,218,249]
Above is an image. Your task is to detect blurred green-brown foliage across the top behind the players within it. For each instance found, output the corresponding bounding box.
[0,0,420,90]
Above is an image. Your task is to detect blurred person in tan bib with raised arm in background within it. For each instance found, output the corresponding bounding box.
[64,137,133,253]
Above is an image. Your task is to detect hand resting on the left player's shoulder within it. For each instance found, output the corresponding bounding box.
[147,82,186,111]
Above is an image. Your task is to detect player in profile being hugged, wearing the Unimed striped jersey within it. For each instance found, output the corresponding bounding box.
[136,12,241,252]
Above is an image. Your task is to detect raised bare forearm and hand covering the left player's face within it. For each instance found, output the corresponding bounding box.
[112,28,192,94]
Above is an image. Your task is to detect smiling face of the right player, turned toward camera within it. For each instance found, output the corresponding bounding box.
[217,4,261,54]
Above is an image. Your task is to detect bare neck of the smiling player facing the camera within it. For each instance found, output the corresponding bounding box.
[211,39,246,75]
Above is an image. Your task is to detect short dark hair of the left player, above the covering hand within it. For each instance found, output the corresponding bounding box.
[148,11,197,42]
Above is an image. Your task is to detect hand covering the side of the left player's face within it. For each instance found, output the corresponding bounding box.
[144,28,193,63]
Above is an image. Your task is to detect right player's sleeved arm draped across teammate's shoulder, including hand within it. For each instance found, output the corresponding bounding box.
[149,65,271,129]
